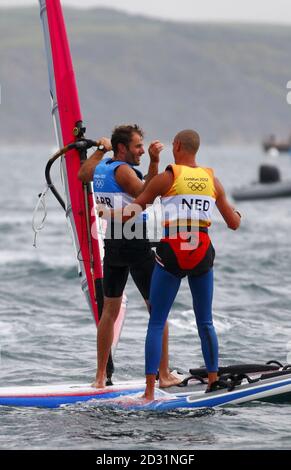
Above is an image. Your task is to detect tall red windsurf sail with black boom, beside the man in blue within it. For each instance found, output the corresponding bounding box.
[39,0,126,373]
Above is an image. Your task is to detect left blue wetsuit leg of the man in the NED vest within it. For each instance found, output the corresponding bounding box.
[145,263,181,374]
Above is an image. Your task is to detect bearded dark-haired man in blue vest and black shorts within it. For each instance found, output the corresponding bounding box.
[78,125,181,388]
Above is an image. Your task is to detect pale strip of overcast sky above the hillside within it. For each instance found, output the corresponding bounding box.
[0,0,291,24]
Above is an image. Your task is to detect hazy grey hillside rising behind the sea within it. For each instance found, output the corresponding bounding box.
[0,8,291,143]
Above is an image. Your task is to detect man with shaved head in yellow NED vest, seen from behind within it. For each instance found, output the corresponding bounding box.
[123,130,241,401]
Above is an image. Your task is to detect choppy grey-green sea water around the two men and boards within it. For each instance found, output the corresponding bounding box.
[0,146,291,450]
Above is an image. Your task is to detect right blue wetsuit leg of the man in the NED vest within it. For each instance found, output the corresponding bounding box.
[188,269,218,372]
